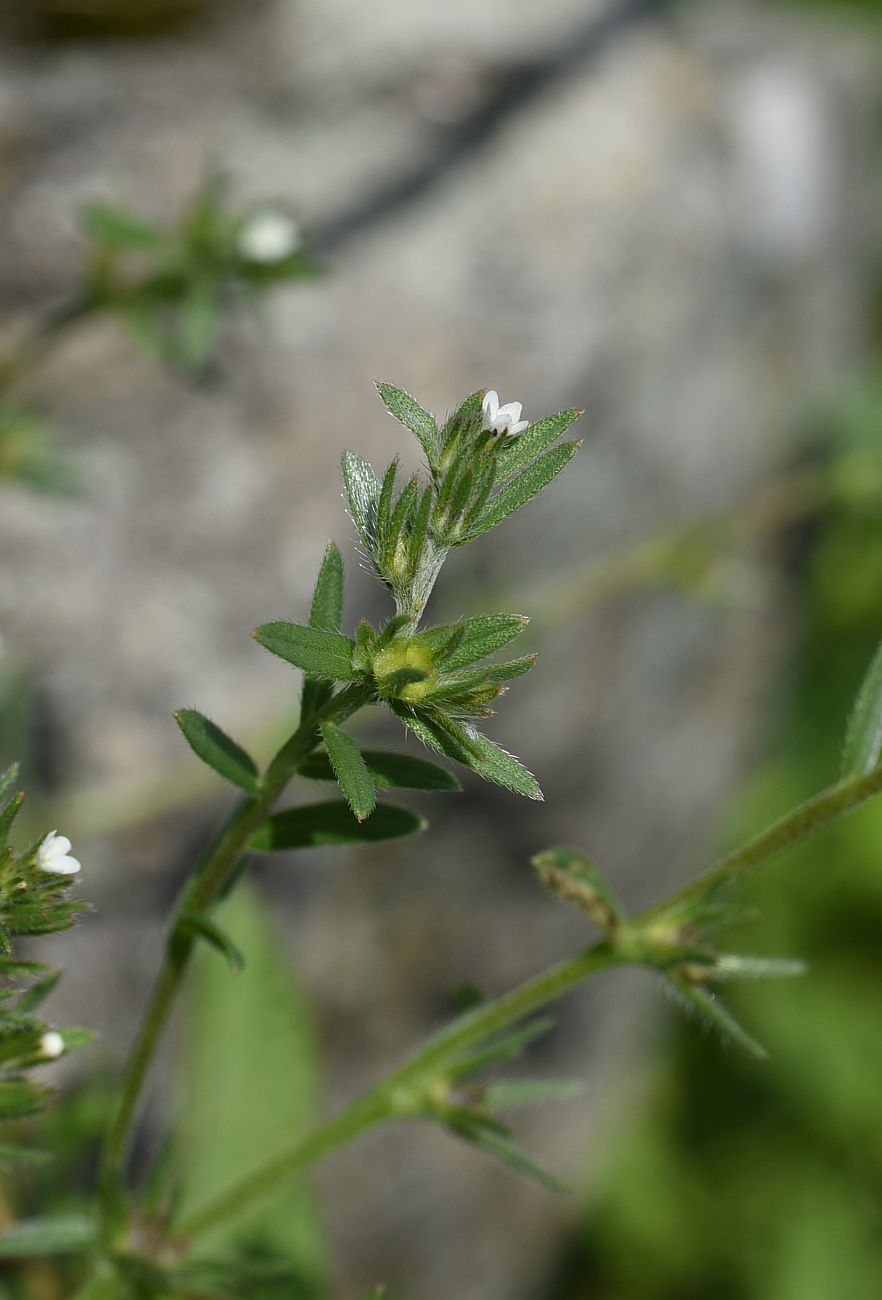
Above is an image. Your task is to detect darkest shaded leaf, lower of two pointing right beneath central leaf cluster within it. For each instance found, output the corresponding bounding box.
[248,800,425,853]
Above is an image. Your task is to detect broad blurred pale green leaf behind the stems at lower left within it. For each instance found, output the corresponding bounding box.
[176,883,328,1300]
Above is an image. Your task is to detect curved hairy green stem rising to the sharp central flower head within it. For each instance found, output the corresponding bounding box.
[99,685,371,1242]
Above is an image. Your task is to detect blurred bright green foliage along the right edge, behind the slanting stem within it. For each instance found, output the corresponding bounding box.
[550,380,882,1300]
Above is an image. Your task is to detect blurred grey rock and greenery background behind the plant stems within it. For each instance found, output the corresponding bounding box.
[0,0,882,1300]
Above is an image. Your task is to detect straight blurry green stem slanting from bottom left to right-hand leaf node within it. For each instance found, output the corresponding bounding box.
[178,941,626,1238]
